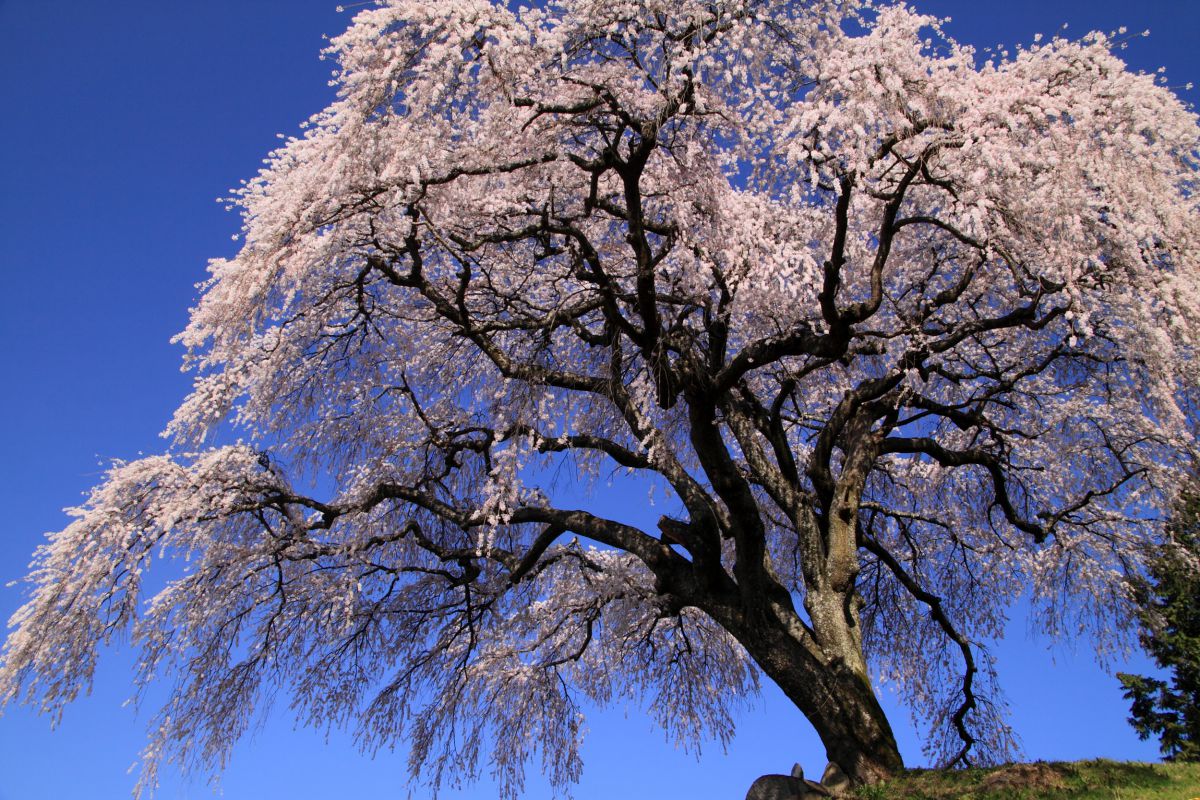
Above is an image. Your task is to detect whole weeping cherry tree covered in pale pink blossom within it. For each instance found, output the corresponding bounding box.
[0,0,1200,796]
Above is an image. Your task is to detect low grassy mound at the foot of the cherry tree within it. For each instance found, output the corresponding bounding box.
[856,760,1200,800]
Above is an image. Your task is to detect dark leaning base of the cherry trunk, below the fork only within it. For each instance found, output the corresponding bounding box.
[700,592,904,784]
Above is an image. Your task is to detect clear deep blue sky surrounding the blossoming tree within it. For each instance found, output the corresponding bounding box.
[0,0,1200,800]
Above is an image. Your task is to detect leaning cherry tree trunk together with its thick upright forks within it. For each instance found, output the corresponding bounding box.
[665,392,904,786]
